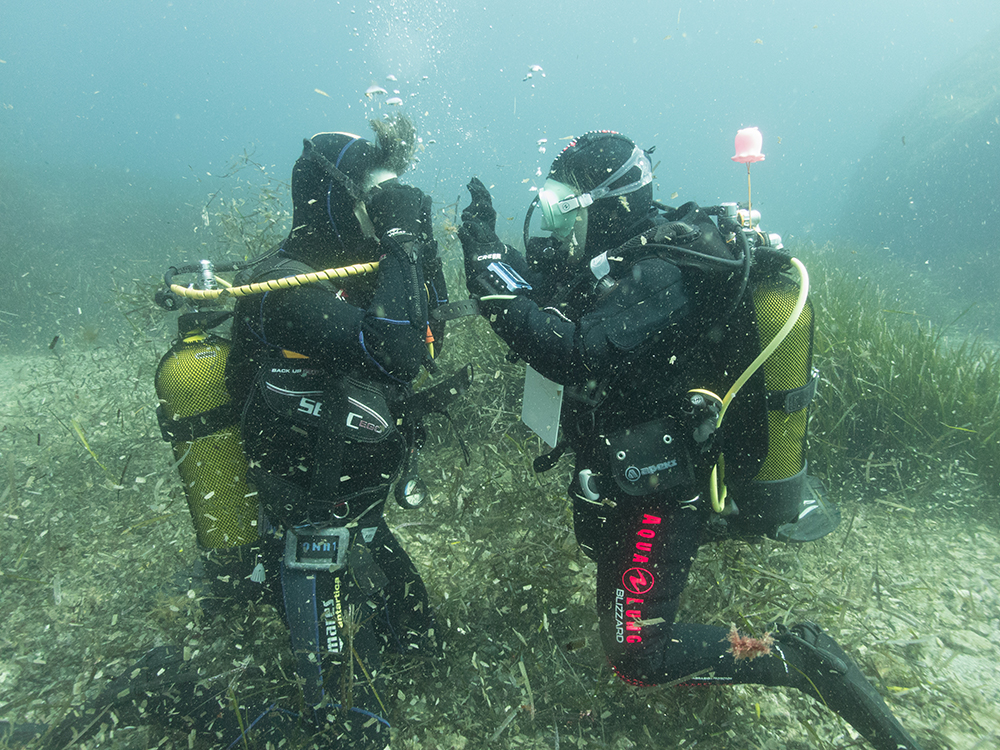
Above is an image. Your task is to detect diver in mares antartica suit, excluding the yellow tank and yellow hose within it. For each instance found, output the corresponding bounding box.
[210,117,446,749]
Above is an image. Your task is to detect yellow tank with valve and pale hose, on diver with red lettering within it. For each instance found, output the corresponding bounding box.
[696,204,840,542]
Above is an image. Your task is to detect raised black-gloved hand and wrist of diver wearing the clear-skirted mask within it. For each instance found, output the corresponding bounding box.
[458,177,531,297]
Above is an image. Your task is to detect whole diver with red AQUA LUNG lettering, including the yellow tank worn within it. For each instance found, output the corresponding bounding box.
[459,131,919,750]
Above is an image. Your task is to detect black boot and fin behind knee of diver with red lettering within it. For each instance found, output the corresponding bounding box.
[775,622,920,750]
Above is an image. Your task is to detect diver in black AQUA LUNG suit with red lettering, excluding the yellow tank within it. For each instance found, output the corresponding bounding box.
[459,131,918,750]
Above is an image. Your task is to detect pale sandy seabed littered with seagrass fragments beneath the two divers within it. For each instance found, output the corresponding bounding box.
[0,337,1000,750]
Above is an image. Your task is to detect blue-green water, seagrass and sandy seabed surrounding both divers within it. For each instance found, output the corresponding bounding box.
[0,0,1000,750]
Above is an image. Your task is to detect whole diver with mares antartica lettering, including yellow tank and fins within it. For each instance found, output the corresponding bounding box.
[12,117,472,750]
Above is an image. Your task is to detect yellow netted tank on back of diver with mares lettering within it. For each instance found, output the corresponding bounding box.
[155,331,259,548]
